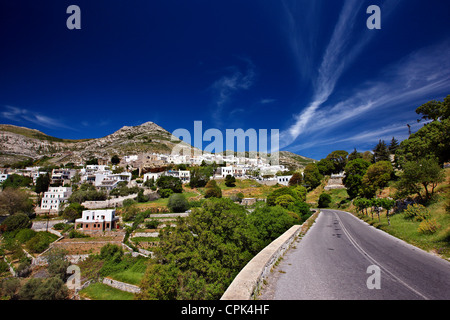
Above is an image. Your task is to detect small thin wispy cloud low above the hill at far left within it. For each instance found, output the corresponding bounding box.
[0,106,73,130]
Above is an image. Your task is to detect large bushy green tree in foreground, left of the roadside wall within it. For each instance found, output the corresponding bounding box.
[137,198,262,300]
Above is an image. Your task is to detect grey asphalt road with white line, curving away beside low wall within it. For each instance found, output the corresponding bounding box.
[260,210,450,300]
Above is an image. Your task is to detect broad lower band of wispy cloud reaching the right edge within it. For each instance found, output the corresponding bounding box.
[294,42,450,141]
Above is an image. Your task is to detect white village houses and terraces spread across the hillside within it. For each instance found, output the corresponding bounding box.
[0,148,312,297]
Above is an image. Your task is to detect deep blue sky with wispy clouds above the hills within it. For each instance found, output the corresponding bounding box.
[0,0,450,159]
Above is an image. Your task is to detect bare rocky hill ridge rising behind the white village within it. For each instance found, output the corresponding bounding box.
[0,122,315,169]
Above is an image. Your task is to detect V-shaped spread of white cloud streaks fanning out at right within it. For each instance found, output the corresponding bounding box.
[280,0,450,151]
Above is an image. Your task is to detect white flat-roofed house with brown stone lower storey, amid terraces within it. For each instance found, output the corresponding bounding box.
[75,209,119,231]
